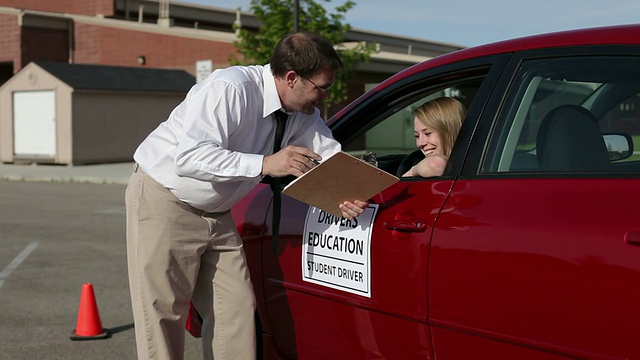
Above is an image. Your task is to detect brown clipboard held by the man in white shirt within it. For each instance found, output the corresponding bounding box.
[282,151,400,217]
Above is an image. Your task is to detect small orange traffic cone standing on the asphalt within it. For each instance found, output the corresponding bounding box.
[71,283,111,340]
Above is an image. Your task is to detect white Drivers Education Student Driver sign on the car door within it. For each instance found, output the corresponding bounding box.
[302,204,378,297]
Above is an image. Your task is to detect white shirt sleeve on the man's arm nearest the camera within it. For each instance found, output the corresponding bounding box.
[174,81,264,182]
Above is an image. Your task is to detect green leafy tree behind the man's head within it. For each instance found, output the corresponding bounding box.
[229,0,375,119]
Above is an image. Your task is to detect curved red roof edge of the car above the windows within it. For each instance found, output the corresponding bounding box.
[330,24,640,123]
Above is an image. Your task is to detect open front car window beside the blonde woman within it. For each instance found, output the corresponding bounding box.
[342,76,484,174]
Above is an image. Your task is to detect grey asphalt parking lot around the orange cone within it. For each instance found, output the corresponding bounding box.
[0,180,201,360]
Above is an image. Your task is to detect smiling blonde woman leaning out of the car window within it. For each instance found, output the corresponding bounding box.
[402,97,466,177]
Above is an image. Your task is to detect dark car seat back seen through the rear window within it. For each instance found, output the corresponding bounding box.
[536,105,611,171]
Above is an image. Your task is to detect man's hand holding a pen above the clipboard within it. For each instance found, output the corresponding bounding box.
[262,145,322,177]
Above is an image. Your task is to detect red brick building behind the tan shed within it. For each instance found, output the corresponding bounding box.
[0,0,462,164]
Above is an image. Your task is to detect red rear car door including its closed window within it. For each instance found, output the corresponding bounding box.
[429,46,640,359]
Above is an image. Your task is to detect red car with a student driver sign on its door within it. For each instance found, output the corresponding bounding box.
[233,25,640,360]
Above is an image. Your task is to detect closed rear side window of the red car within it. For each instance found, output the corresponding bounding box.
[483,56,640,173]
